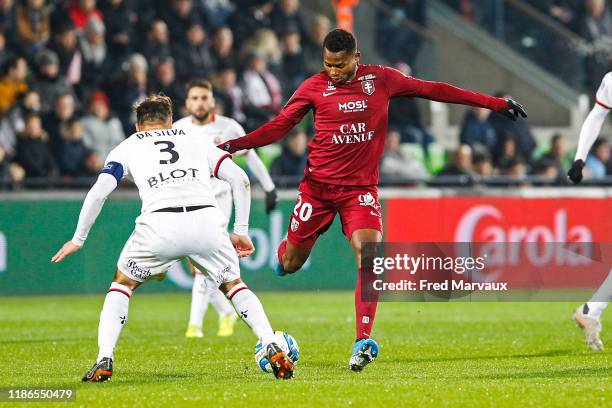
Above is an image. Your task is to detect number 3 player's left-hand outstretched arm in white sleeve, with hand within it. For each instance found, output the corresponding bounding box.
[51,173,117,263]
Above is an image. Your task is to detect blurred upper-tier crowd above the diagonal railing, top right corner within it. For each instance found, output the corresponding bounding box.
[444,0,612,92]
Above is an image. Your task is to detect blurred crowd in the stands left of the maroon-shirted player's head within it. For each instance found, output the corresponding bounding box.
[0,0,332,184]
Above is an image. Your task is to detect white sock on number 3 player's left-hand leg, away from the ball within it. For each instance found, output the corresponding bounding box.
[97,282,132,361]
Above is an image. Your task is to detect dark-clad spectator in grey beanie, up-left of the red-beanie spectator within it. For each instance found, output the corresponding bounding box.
[34,50,74,114]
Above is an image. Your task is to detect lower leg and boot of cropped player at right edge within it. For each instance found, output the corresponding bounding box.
[574,270,612,350]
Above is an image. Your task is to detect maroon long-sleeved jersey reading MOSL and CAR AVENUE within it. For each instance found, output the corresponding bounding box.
[224,65,508,186]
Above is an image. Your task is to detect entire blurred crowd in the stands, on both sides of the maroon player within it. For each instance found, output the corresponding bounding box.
[0,0,612,188]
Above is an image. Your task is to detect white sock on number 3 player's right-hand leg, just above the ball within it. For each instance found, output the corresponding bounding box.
[226,282,274,338]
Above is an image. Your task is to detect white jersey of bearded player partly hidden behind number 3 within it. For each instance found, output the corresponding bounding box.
[172,114,246,199]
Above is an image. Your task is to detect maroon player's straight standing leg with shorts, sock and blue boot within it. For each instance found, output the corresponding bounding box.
[337,187,382,371]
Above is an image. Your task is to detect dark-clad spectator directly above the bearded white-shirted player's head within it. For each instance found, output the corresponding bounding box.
[173,24,213,81]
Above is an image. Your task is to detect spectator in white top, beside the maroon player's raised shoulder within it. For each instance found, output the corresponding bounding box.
[242,52,283,131]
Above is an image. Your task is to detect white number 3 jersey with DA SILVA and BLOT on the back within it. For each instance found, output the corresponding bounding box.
[105,129,231,212]
